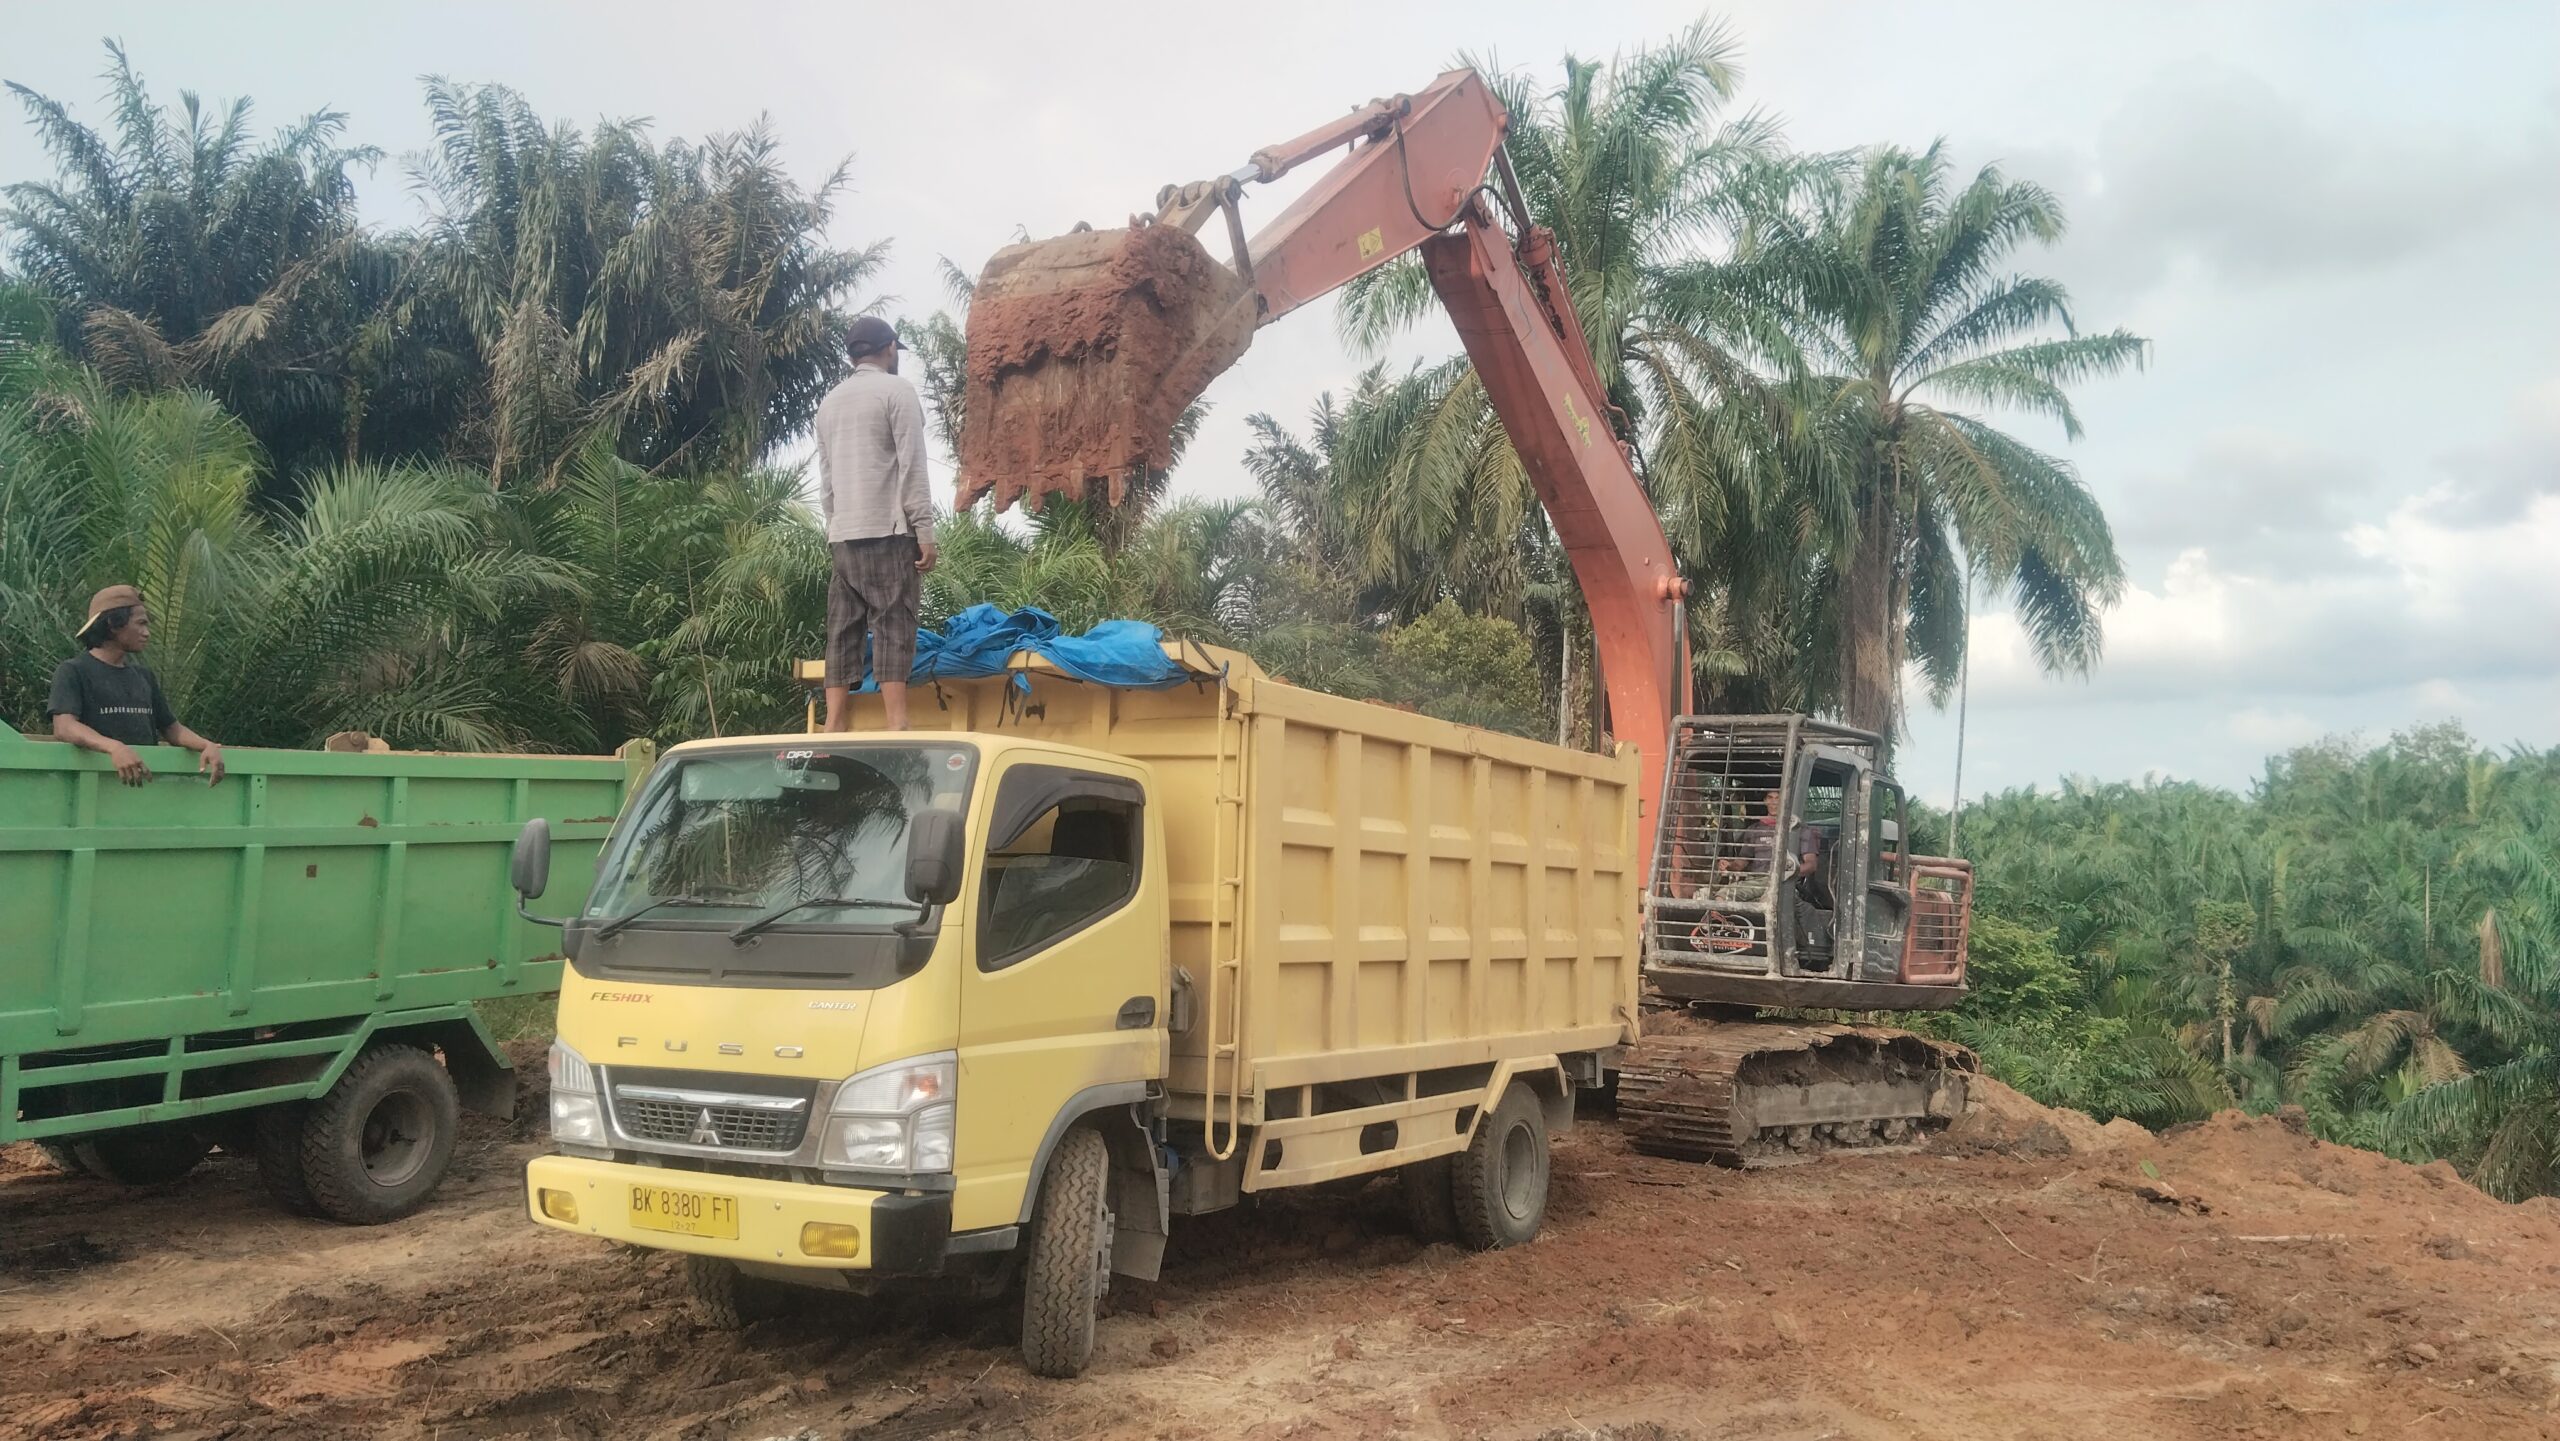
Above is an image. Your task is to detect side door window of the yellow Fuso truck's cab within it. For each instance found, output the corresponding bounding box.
[978,765,1144,970]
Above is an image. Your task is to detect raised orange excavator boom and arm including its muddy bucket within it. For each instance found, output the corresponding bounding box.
[960,69,1690,845]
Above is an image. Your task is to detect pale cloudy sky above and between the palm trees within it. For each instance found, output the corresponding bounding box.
[0,0,2560,801]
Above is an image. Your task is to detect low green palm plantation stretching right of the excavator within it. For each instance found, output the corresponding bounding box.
[1948,727,2560,1195]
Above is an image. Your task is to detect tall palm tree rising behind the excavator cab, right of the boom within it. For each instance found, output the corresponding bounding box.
[1751,143,2148,752]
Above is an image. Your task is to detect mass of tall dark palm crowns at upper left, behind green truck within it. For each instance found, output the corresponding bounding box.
[0,44,886,507]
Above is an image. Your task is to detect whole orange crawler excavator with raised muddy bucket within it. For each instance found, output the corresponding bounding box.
[960,69,1974,1165]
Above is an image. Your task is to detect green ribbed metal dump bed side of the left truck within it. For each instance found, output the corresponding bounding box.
[0,732,653,1139]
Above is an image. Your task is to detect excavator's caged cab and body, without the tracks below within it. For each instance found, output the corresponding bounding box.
[1644,717,1974,1011]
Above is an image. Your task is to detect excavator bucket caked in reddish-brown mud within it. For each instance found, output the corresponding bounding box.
[957,225,1260,509]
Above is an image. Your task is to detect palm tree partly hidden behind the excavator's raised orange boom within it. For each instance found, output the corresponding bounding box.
[1336,23,1792,614]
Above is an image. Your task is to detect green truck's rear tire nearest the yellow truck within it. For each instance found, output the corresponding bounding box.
[302,1044,461,1226]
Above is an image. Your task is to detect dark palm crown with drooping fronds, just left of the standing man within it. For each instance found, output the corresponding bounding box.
[410,79,886,484]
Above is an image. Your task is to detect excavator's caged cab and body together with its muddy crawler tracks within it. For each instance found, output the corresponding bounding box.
[1618,717,1976,1167]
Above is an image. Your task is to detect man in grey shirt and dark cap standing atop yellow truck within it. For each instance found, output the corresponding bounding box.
[817,315,934,732]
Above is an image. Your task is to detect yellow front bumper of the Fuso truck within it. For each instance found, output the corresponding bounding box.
[525,1154,952,1275]
